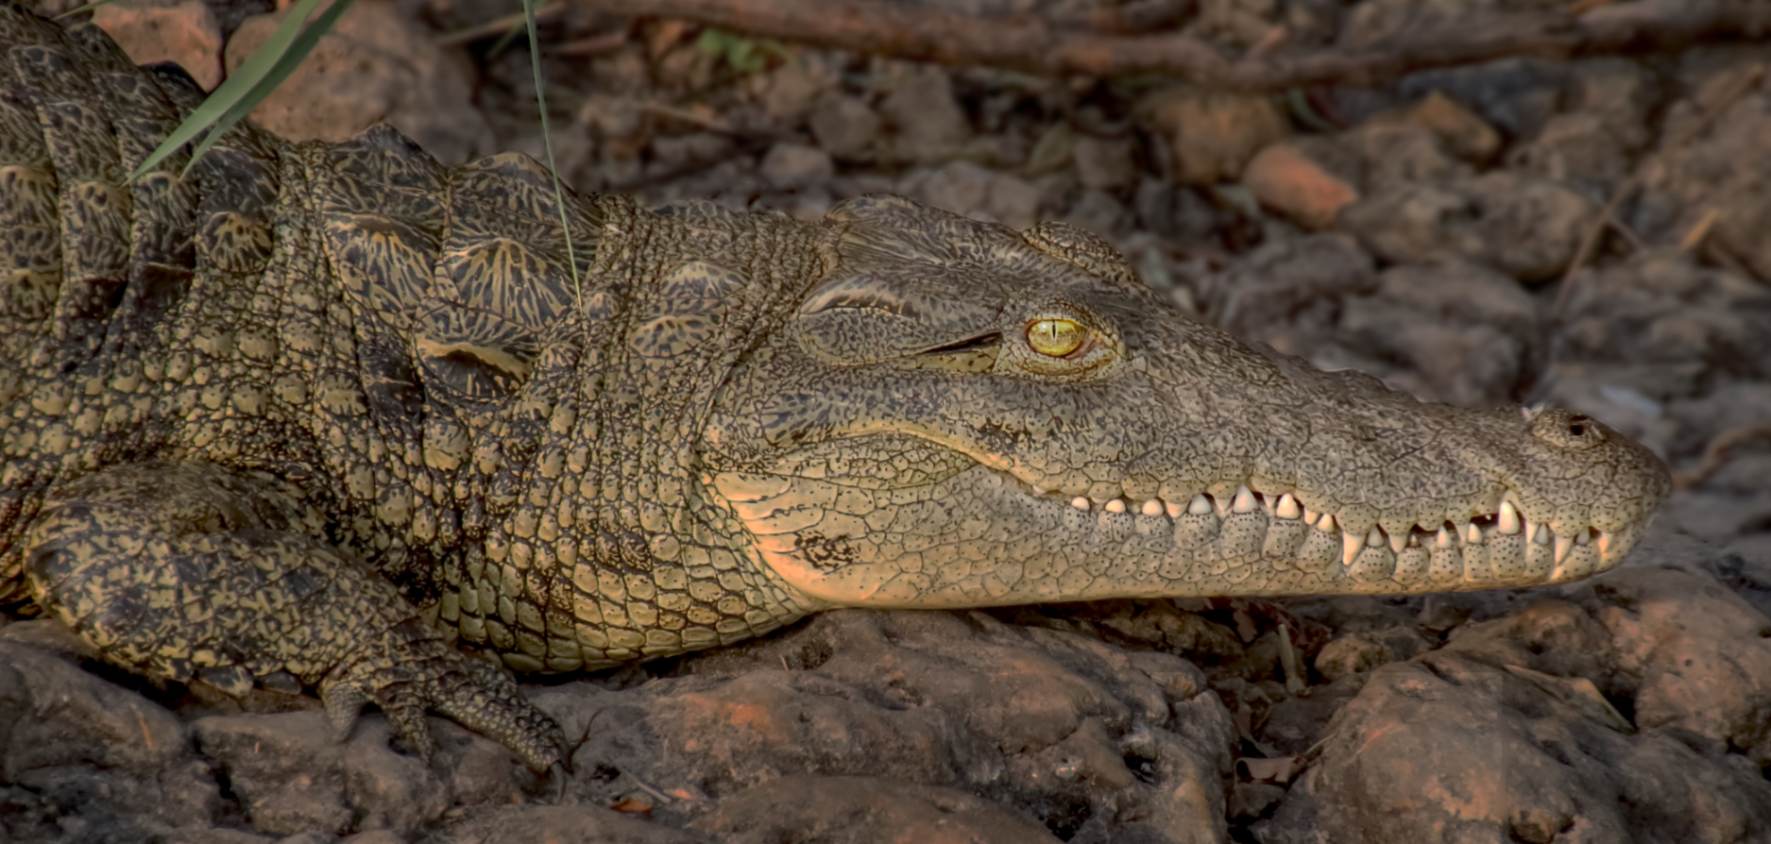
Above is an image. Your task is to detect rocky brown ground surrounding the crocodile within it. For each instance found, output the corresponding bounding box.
[10,0,1771,844]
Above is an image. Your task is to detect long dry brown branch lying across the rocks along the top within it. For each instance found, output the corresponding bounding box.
[574,0,1771,92]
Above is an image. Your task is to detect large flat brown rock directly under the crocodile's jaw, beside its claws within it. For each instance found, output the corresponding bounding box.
[535,610,1234,840]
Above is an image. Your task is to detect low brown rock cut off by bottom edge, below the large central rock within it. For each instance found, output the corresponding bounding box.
[689,777,1059,844]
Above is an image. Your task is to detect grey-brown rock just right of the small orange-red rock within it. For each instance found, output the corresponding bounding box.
[1341,170,1596,280]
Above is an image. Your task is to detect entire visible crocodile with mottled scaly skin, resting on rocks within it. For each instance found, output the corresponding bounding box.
[0,5,1668,768]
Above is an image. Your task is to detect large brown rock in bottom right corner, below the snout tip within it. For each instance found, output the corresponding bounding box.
[1256,540,1771,842]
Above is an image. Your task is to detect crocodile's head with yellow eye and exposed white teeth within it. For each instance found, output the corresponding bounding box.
[701,196,1670,607]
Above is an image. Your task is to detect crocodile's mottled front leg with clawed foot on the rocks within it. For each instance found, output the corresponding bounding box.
[25,462,565,771]
